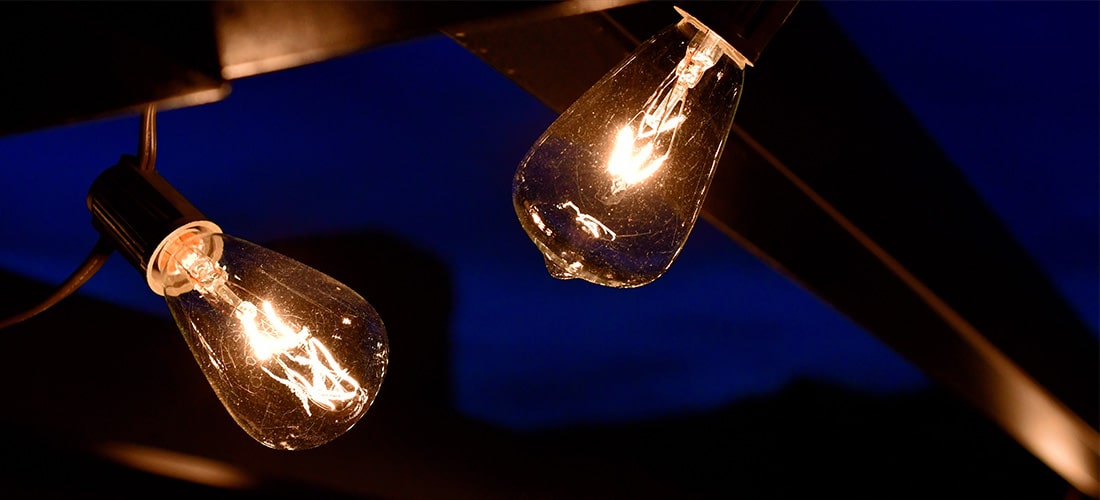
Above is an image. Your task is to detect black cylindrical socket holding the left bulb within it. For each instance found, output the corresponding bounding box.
[88,155,221,295]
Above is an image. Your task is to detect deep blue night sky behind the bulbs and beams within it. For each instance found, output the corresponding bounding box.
[0,2,1100,427]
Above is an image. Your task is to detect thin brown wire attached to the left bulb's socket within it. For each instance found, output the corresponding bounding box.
[0,104,156,330]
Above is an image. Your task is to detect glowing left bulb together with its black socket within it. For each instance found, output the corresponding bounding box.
[88,157,388,449]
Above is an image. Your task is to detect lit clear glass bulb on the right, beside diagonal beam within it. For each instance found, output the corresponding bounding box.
[513,9,747,288]
